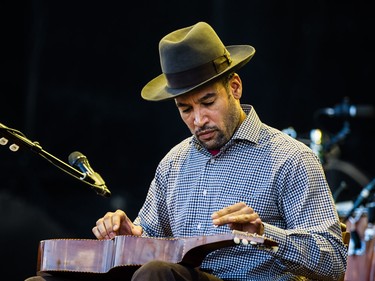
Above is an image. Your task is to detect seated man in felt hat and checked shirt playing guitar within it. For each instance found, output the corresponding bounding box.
[29,22,347,281]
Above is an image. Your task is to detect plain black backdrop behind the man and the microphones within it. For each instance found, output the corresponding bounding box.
[0,0,375,280]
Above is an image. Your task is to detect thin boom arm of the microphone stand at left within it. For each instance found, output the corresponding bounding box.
[0,123,111,197]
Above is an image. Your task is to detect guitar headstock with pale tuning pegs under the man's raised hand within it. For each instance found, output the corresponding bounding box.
[232,230,278,251]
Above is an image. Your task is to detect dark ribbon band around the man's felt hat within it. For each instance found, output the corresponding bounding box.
[165,53,232,89]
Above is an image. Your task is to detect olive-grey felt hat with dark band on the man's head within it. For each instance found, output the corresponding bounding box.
[141,22,255,101]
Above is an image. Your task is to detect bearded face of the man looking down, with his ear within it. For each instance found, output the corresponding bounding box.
[175,75,243,149]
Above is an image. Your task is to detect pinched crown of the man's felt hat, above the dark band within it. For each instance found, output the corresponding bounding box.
[159,22,228,74]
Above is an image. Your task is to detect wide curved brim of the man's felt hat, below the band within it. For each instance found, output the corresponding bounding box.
[141,45,255,101]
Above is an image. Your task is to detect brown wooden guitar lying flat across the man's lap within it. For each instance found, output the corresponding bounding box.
[37,232,277,278]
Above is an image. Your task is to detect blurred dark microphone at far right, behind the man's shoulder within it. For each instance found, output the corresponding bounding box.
[321,99,375,118]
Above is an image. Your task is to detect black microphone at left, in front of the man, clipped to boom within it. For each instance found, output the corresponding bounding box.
[68,151,111,197]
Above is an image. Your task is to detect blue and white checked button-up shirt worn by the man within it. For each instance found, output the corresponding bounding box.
[135,105,347,281]
